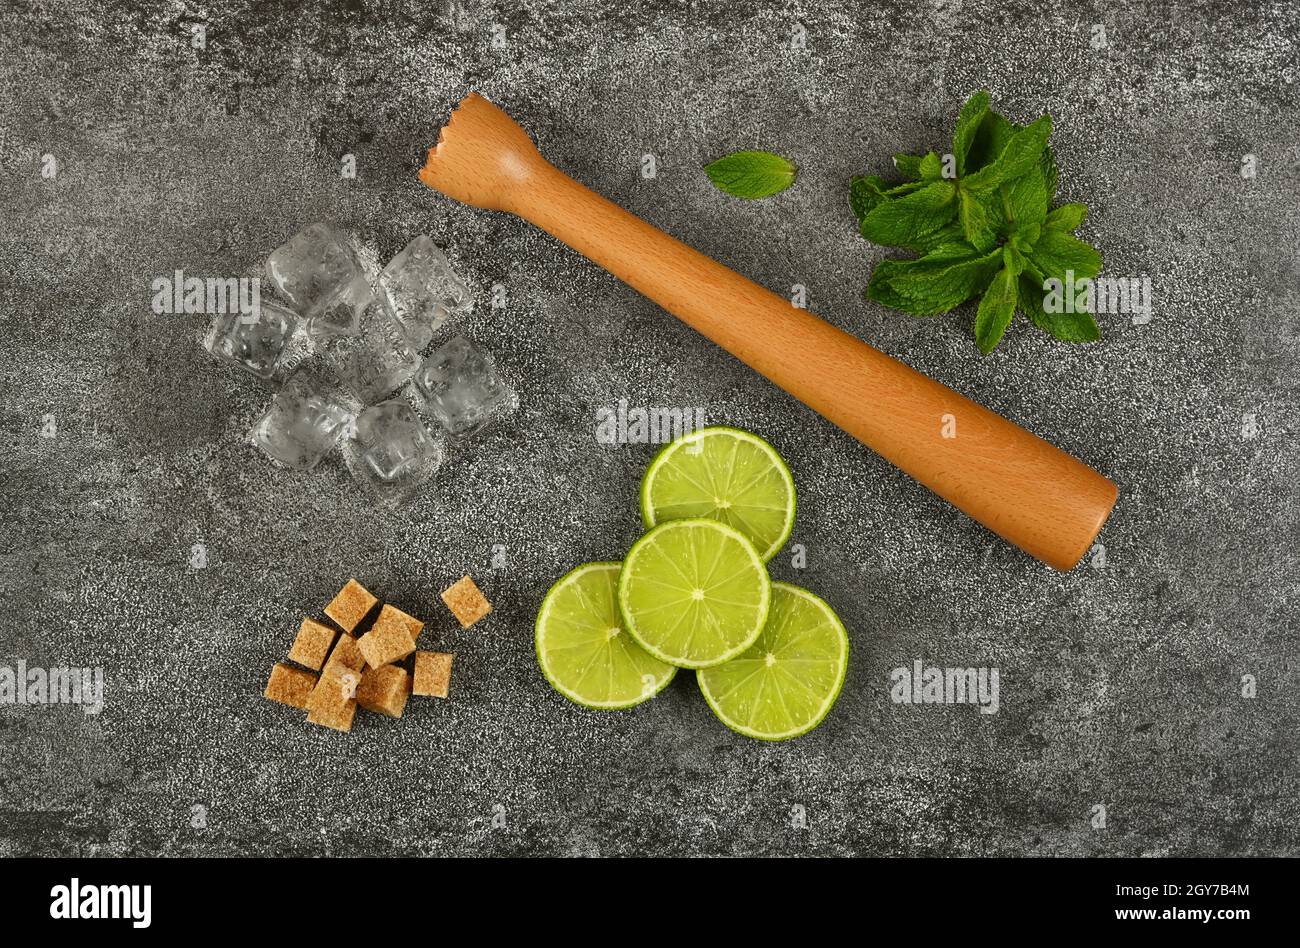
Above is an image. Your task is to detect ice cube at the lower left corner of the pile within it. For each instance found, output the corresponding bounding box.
[248,369,352,471]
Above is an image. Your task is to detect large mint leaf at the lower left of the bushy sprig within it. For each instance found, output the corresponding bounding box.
[871,243,1001,316]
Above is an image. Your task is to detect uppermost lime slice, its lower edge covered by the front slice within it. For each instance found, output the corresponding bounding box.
[641,427,794,563]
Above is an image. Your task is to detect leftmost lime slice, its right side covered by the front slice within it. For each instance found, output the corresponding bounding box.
[536,563,677,709]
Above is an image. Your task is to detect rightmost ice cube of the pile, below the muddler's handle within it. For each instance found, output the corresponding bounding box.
[415,336,519,437]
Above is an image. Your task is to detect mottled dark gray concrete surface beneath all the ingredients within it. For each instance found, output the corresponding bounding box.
[0,0,1300,856]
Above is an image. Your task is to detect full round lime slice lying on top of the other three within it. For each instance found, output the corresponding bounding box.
[619,520,772,668]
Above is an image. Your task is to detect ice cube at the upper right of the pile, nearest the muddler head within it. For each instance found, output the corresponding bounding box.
[378,234,475,349]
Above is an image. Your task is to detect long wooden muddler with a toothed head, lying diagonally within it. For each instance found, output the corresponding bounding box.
[420,94,1117,570]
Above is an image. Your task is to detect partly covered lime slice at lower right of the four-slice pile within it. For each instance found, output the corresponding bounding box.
[696,583,849,741]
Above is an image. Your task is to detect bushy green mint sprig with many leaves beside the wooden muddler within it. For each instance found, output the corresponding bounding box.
[849,91,1101,355]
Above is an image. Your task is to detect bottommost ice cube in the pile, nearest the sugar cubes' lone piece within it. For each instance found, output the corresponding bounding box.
[343,397,443,506]
